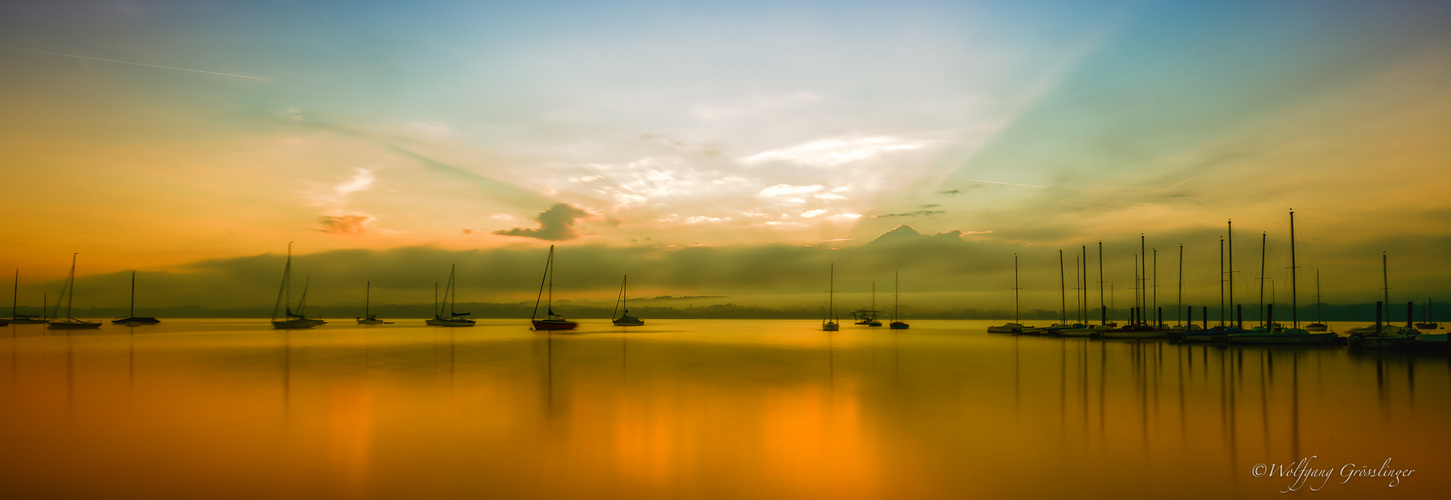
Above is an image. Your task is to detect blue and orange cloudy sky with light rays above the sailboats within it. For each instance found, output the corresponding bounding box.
[0,0,1451,315]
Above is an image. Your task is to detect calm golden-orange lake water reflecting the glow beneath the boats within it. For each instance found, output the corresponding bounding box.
[0,319,1451,499]
